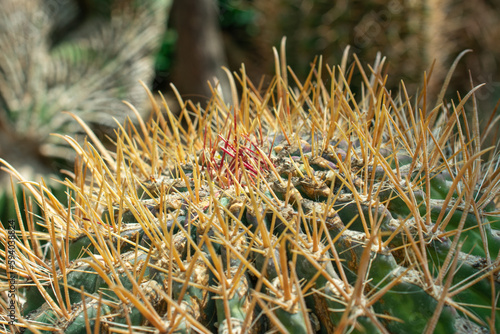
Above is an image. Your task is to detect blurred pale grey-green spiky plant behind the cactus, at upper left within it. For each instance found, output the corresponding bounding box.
[0,0,170,219]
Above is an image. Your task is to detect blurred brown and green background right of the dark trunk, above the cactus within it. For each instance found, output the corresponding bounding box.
[157,0,500,109]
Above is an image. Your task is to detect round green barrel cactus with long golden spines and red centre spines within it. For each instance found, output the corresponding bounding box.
[2,45,500,333]
